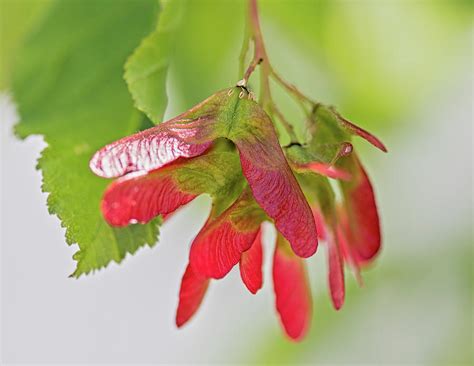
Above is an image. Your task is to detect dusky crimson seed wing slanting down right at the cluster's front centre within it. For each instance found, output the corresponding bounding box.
[229,99,318,257]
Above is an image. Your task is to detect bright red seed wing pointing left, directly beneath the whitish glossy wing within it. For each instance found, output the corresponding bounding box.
[102,152,243,226]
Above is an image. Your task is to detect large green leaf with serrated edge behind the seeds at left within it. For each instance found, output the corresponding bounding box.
[13,0,159,277]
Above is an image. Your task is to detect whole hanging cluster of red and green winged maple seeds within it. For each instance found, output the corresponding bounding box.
[90,87,385,339]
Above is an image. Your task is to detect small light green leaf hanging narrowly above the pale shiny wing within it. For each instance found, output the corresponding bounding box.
[125,0,183,123]
